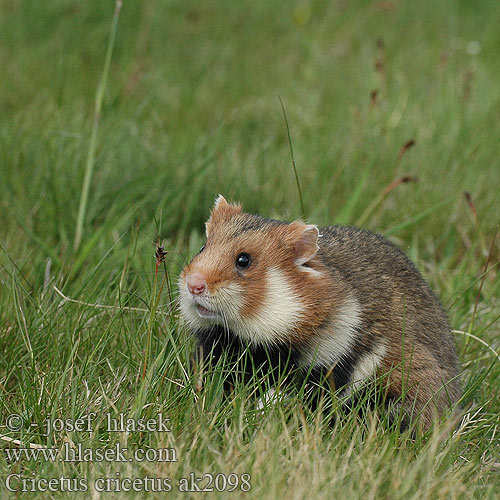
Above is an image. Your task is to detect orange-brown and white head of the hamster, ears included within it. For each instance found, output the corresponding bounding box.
[179,196,330,345]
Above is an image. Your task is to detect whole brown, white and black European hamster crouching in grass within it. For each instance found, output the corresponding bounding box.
[179,196,460,428]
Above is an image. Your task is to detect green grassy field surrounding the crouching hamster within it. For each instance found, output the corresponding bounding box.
[0,0,500,499]
